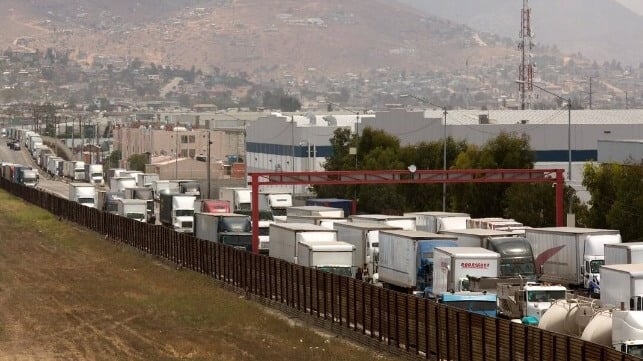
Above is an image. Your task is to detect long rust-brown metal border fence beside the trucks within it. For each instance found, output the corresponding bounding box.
[0,179,639,361]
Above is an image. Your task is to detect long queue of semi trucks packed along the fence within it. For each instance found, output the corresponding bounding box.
[2,129,643,356]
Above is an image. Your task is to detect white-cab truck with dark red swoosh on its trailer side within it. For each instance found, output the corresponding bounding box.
[525,227,621,288]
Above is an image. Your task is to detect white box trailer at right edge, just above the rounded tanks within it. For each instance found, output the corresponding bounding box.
[600,263,643,310]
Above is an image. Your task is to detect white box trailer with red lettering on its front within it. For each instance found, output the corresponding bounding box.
[430,247,500,297]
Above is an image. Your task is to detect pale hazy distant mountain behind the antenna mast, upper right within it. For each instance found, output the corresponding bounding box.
[399,0,643,66]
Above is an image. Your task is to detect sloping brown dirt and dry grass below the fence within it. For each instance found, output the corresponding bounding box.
[0,191,402,361]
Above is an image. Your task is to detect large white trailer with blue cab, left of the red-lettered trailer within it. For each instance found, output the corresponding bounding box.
[378,230,458,296]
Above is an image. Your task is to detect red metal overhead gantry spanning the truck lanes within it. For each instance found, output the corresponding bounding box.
[248,169,564,253]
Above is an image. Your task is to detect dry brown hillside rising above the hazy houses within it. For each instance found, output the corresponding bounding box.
[0,0,515,79]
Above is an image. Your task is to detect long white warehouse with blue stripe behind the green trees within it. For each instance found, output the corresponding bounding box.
[247,108,643,195]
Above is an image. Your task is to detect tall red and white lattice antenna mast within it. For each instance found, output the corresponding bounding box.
[518,0,534,110]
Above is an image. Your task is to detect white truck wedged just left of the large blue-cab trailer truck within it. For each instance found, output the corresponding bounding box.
[334,222,401,282]
